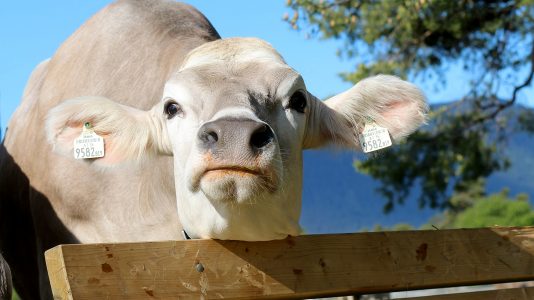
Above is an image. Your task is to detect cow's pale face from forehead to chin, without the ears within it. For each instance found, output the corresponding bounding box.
[161,39,309,240]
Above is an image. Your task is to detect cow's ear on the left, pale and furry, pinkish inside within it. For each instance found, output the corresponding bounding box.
[46,97,172,165]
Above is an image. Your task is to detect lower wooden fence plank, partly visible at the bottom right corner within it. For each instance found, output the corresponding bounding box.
[399,287,534,300]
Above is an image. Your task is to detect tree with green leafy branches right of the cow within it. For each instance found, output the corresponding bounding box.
[285,0,534,211]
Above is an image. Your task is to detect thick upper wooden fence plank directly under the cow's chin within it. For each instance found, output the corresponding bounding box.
[46,227,534,299]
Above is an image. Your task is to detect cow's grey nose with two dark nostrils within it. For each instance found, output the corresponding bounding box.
[198,119,274,151]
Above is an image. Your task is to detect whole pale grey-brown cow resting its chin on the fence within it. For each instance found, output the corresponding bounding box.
[0,0,427,299]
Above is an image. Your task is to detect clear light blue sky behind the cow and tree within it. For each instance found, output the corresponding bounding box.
[0,0,534,128]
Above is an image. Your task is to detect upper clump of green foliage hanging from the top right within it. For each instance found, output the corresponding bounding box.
[287,0,534,81]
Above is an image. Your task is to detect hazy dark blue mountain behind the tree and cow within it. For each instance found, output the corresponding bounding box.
[301,107,534,233]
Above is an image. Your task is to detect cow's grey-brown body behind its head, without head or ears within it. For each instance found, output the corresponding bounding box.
[0,0,219,298]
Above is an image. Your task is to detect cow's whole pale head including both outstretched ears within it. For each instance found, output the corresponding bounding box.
[47,38,426,240]
